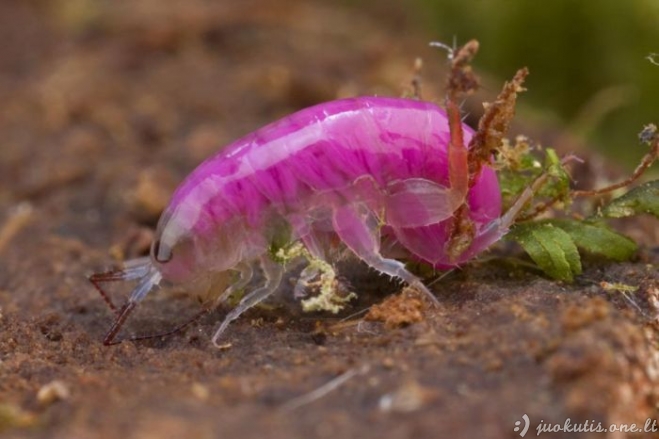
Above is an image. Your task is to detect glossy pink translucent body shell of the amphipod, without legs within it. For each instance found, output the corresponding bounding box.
[157,97,501,278]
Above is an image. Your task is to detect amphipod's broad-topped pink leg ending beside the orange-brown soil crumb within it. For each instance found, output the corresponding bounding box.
[333,206,438,303]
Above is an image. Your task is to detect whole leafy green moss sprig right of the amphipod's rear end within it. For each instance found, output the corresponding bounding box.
[498,125,659,281]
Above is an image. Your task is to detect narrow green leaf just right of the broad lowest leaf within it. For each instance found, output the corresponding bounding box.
[547,219,637,261]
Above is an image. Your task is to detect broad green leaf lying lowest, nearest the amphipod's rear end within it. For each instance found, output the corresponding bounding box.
[506,222,581,281]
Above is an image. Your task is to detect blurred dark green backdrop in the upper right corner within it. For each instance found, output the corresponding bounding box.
[419,0,659,166]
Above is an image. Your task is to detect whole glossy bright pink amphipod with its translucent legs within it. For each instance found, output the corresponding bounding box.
[92,97,514,344]
